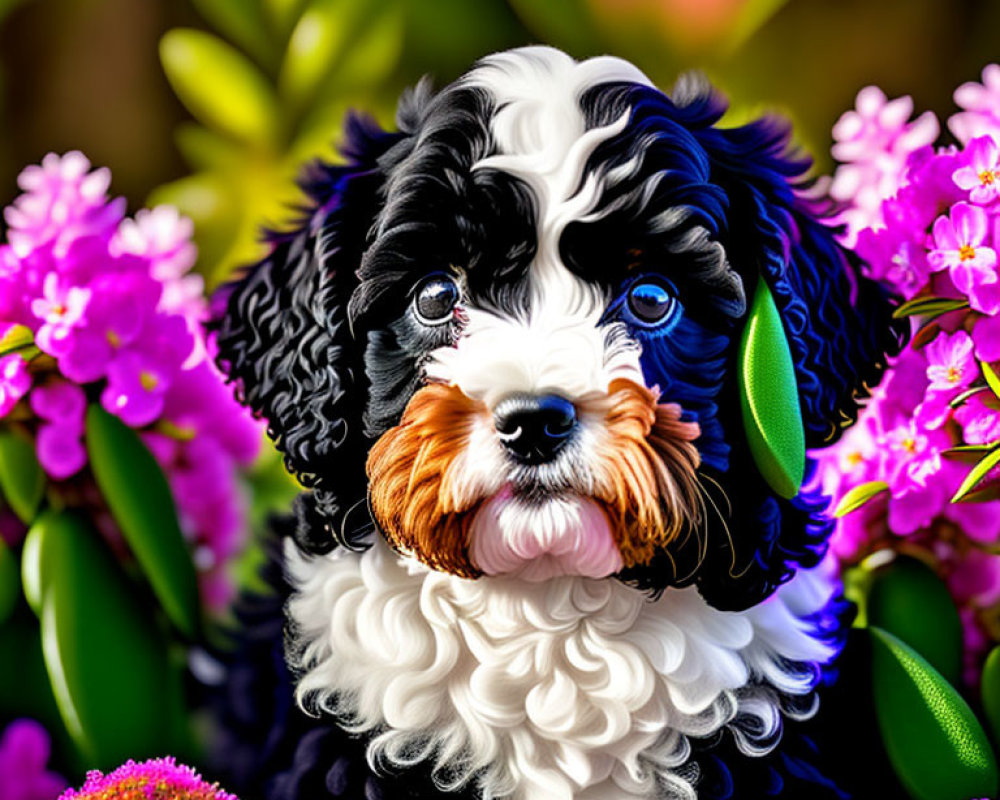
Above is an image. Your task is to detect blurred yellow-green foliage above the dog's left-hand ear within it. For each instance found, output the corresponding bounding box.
[151,0,405,288]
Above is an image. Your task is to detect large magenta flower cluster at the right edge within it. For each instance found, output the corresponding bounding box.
[817,65,1000,677]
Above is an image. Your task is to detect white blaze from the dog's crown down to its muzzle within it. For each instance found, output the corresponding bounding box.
[427,47,651,406]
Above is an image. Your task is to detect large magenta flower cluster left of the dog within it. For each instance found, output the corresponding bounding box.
[0,152,260,605]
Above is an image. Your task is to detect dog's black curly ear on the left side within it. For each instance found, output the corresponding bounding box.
[213,112,405,552]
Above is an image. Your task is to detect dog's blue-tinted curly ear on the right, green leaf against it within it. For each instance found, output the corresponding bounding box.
[680,95,905,608]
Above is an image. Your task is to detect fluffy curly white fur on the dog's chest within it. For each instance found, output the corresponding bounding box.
[287,538,833,800]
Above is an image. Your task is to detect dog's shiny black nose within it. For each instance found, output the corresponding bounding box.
[493,394,576,464]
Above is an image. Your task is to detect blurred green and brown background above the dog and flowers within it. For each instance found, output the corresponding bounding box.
[0,0,1000,292]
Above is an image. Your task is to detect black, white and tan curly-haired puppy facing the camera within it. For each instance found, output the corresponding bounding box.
[216,47,902,800]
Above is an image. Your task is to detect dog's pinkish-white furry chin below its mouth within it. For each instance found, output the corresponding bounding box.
[469,487,624,581]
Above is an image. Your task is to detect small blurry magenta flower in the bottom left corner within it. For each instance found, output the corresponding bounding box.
[0,719,66,800]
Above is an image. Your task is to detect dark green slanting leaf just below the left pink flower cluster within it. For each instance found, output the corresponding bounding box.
[87,405,198,636]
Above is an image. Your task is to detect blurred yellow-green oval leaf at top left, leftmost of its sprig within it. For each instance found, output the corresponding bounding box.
[160,28,278,147]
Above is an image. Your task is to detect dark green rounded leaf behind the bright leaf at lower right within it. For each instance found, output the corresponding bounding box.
[866,556,962,686]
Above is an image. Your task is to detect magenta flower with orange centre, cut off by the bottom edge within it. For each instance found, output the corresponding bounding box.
[59,756,238,800]
